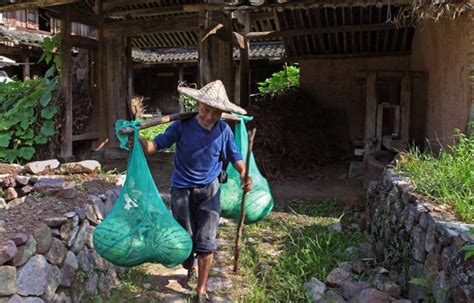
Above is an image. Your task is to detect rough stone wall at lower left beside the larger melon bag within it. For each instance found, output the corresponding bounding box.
[0,161,124,303]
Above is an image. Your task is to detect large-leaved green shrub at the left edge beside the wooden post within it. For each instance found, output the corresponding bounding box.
[0,36,61,163]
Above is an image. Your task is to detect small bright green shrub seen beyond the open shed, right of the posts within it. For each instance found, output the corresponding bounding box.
[258,65,300,95]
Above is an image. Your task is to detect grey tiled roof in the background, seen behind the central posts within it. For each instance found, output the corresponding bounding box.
[132,42,285,64]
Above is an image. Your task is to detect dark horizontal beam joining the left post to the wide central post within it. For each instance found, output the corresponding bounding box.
[104,14,198,36]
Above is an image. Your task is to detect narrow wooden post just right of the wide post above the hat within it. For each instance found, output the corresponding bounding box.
[235,11,250,106]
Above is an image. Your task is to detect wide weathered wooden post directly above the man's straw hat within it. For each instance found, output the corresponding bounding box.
[198,10,234,100]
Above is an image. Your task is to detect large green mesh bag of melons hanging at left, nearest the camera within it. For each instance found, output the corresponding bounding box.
[93,120,192,267]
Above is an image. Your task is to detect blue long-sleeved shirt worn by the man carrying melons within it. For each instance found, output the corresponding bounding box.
[155,117,242,188]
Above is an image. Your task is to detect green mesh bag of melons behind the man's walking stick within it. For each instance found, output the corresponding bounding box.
[221,116,273,224]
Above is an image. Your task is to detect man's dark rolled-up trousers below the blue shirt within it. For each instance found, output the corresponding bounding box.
[171,179,221,254]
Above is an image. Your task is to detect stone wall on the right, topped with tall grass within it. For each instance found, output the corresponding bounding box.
[368,170,474,302]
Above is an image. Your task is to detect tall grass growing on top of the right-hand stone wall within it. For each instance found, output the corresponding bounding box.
[397,131,474,222]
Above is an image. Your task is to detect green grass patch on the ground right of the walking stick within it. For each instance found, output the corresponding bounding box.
[221,201,364,302]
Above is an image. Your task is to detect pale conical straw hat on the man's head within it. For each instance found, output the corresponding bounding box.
[178,80,247,115]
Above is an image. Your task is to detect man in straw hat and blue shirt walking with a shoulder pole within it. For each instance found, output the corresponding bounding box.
[136,80,252,302]
